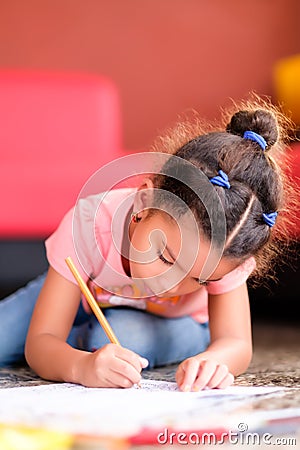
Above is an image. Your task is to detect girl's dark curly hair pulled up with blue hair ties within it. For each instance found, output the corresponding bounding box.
[154,97,290,284]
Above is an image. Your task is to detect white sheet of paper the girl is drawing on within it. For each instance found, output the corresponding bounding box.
[0,380,280,436]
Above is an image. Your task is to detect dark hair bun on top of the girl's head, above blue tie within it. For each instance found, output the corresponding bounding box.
[226,109,279,150]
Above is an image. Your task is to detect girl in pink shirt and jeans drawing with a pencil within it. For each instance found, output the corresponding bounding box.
[0,97,292,391]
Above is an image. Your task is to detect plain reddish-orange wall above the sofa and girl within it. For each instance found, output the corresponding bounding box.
[0,0,300,150]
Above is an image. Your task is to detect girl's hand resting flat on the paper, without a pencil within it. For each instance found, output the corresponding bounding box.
[176,355,234,392]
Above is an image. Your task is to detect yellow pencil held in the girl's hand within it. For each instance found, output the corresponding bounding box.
[66,256,121,345]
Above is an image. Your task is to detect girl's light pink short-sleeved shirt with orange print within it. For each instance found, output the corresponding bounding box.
[46,188,255,322]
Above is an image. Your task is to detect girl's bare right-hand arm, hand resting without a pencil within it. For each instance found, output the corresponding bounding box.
[176,283,252,391]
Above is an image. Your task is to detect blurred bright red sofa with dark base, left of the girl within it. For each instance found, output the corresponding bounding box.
[0,70,122,296]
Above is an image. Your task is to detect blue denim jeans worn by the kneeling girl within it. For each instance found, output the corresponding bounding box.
[0,275,209,368]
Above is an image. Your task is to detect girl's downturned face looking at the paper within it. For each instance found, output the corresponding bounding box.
[129,211,238,297]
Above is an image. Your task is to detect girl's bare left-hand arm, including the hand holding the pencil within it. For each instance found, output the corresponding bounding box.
[25,267,147,387]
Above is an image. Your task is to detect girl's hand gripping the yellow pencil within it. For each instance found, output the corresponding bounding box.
[80,344,148,388]
